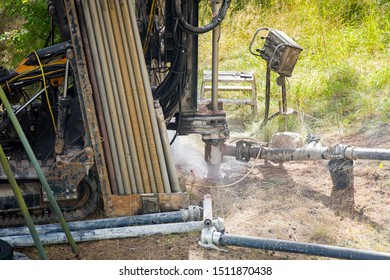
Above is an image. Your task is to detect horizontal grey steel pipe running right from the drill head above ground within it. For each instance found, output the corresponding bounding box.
[223,145,390,161]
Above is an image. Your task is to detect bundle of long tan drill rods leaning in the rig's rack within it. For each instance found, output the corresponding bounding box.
[79,0,180,194]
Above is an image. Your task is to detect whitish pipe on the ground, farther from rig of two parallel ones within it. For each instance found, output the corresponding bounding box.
[2,221,204,247]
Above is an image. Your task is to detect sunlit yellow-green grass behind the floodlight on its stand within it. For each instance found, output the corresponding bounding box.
[199,0,390,136]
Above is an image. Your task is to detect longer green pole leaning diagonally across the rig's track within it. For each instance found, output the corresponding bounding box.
[0,87,79,254]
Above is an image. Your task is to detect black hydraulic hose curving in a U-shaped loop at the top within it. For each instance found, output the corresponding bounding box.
[175,0,230,34]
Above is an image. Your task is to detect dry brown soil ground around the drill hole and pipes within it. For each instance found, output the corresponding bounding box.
[18,124,390,260]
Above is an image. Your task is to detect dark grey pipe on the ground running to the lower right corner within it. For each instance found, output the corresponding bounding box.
[219,234,390,260]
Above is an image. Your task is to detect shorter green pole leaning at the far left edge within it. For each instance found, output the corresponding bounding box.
[0,145,47,260]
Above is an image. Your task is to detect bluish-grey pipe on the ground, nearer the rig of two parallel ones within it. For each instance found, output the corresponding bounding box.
[0,206,200,238]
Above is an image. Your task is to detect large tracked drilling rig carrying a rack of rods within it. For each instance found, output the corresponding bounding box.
[0,0,230,226]
